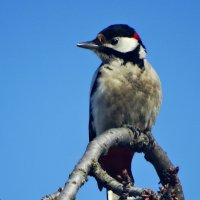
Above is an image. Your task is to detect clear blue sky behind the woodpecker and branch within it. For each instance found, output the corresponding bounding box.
[0,0,200,200]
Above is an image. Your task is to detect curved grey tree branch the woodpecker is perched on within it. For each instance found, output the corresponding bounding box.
[43,128,184,200]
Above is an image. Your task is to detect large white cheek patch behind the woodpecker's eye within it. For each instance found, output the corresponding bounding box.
[109,37,139,53]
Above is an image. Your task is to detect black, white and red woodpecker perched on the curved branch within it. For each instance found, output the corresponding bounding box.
[77,24,162,200]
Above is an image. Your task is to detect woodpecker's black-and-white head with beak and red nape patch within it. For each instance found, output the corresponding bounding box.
[77,24,146,63]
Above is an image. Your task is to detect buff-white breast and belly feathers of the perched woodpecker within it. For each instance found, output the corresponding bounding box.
[91,60,162,135]
